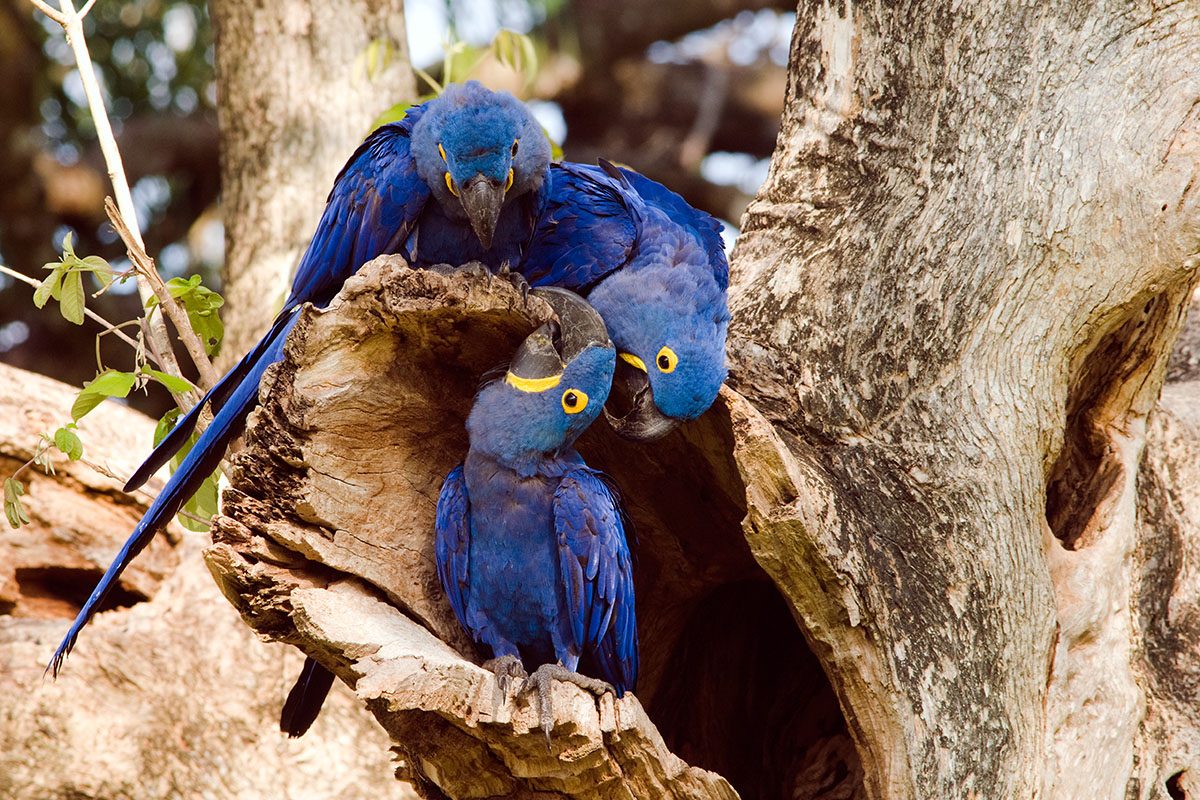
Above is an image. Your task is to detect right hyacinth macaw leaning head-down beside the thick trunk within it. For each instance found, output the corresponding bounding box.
[518,161,730,440]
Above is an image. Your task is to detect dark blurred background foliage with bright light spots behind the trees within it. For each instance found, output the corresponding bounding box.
[0,0,794,416]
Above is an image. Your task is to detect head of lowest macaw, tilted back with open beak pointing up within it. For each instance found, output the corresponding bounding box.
[467,287,616,473]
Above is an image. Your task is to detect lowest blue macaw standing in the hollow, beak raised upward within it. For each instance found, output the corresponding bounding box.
[434,288,637,738]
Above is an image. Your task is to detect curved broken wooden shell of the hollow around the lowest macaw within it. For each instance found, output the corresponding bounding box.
[206,257,737,799]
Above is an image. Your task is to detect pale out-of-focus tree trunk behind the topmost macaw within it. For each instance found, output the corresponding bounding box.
[210,0,416,367]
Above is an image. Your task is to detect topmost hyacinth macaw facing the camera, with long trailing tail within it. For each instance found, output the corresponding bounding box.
[47,82,550,675]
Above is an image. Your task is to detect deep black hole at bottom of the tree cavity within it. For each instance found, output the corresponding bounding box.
[649,581,863,800]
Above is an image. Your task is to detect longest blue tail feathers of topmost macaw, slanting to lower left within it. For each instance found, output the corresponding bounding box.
[46,317,295,678]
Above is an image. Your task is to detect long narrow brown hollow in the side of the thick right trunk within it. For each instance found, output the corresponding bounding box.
[1046,291,1172,551]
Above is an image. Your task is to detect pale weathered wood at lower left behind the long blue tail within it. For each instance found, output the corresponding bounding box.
[0,365,413,800]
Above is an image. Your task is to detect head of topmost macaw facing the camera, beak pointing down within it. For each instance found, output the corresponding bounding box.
[412,80,550,248]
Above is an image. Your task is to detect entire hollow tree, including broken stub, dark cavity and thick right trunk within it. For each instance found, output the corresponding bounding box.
[209,2,1200,800]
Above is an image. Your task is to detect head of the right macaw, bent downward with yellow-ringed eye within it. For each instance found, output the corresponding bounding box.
[588,261,730,441]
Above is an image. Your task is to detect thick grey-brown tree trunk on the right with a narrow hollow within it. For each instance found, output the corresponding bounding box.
[731,2,1200,799]
